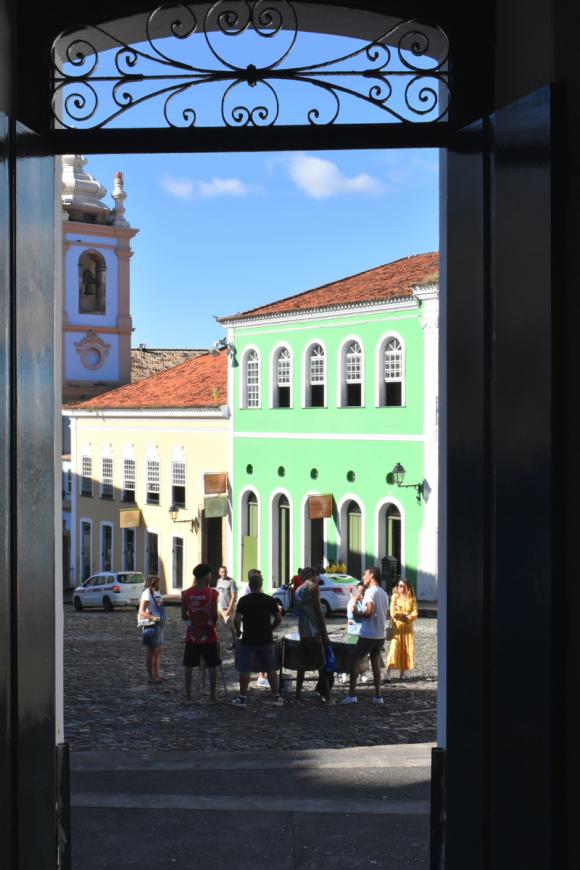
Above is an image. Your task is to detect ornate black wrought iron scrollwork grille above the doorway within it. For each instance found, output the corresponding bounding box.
[52,0,450,129]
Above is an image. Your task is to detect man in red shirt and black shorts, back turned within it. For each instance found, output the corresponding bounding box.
[181,562,221,704]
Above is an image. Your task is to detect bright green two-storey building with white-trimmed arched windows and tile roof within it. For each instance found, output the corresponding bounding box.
[220,253,439,600]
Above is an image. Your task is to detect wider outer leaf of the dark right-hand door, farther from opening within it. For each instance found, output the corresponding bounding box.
[490,88,555,870]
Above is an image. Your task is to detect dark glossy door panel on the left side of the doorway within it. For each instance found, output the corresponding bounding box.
[12,121,60,870]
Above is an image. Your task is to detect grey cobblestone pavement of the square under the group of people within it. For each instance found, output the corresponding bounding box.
[64,605,437,753]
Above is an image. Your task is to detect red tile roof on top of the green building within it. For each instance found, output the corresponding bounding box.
[218,253,439,323]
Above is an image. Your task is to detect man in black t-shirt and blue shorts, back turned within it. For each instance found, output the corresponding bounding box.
[232,569,284,707]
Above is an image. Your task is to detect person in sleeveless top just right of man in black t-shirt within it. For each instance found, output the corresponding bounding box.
[296,568,331,701]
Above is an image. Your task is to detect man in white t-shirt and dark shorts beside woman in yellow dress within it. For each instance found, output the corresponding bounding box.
[340,566,389,704]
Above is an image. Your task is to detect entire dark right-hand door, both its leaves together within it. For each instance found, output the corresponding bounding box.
[446,89,554,870]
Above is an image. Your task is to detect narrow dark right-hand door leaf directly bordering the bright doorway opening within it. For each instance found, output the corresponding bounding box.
[446,117,489,870]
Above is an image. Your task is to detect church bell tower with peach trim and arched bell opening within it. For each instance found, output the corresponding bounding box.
[62,154,138,404]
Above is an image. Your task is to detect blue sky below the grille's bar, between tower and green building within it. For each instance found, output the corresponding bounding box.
[86,150,439,347]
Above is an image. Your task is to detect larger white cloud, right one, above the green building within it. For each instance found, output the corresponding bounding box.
[288,154,386,199]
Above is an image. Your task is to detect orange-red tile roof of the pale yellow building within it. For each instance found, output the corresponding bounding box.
[70,351,228,410]
